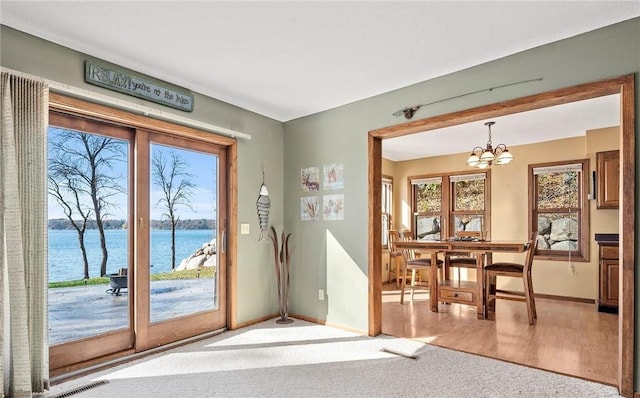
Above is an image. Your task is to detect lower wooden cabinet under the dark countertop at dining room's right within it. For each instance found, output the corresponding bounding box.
[598,242,620,313]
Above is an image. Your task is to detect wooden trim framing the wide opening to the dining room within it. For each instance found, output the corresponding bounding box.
[369,75,635,396]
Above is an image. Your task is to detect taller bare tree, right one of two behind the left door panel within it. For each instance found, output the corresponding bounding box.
[49,129,126,276]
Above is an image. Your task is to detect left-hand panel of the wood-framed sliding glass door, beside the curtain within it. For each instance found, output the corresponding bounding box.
[48,113,133,368]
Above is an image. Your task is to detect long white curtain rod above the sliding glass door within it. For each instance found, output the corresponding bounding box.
[2,66,251,140]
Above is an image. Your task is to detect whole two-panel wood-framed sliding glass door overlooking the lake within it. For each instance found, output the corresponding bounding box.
[48,105,229,374]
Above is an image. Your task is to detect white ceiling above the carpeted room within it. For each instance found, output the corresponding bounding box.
[0,0,640,157]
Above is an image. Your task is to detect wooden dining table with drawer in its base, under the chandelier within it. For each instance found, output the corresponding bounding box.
[396,239,527,319]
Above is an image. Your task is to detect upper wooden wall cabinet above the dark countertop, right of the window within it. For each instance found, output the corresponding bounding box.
[596,150,620,209]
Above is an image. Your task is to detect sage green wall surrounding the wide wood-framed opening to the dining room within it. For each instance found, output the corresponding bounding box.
[284,14,640,366]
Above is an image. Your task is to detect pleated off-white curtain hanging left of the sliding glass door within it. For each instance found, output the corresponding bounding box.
[0,69,49,398]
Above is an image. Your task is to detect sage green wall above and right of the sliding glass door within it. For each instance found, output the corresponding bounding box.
[0,26,284,323]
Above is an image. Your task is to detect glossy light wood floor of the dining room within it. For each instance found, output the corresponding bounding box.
[382,283,618,385]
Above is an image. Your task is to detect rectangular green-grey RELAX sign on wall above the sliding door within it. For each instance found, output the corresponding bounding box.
[84,60,193,112]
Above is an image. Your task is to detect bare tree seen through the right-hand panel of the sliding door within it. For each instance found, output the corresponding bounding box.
[152,150,196,271]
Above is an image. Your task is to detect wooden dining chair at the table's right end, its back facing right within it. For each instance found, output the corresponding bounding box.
[484,232,538,325]
